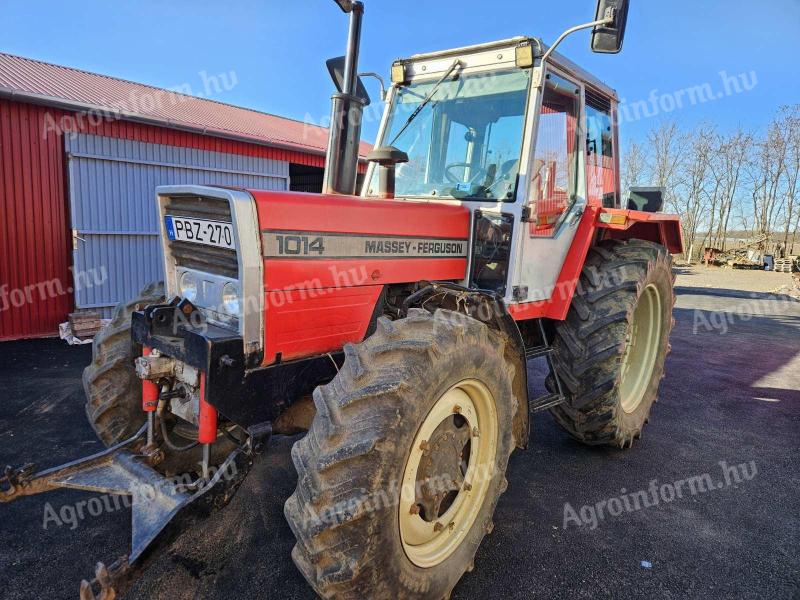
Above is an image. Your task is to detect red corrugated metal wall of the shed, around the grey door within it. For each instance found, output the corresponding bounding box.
[0,99,325,340]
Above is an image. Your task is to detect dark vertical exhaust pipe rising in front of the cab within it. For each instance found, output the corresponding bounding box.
[322,0,365,194]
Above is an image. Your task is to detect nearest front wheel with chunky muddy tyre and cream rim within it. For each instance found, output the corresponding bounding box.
[284,309,518,600]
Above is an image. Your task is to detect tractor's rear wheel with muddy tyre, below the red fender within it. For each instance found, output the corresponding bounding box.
[548,240,675,448]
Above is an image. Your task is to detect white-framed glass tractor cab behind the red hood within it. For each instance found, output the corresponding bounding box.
[361,37,620,304]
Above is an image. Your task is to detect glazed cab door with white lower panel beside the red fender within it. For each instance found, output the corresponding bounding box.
[512,70,586,303]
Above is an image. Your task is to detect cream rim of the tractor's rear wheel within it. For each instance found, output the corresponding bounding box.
[619,283,662,413]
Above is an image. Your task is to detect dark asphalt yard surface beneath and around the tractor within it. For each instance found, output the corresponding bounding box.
[0,269,800,600]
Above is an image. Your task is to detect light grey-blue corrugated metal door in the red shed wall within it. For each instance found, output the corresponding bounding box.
[65,134,289,316]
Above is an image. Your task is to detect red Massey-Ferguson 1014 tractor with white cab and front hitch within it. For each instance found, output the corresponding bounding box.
[0,0,682,600]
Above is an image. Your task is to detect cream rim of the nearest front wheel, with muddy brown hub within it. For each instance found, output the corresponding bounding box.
[399,379,498,568]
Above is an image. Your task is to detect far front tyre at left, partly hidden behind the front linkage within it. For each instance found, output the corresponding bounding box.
[83,282,164,446]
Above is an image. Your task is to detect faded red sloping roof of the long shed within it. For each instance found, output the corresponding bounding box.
[0,52,372,155]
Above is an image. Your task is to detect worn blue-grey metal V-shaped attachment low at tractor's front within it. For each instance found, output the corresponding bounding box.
[0,426,254,600]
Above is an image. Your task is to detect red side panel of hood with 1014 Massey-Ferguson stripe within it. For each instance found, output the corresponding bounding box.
[250,190,470,364]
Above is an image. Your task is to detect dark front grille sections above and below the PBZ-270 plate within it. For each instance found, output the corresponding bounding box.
[164,196,239,279]
